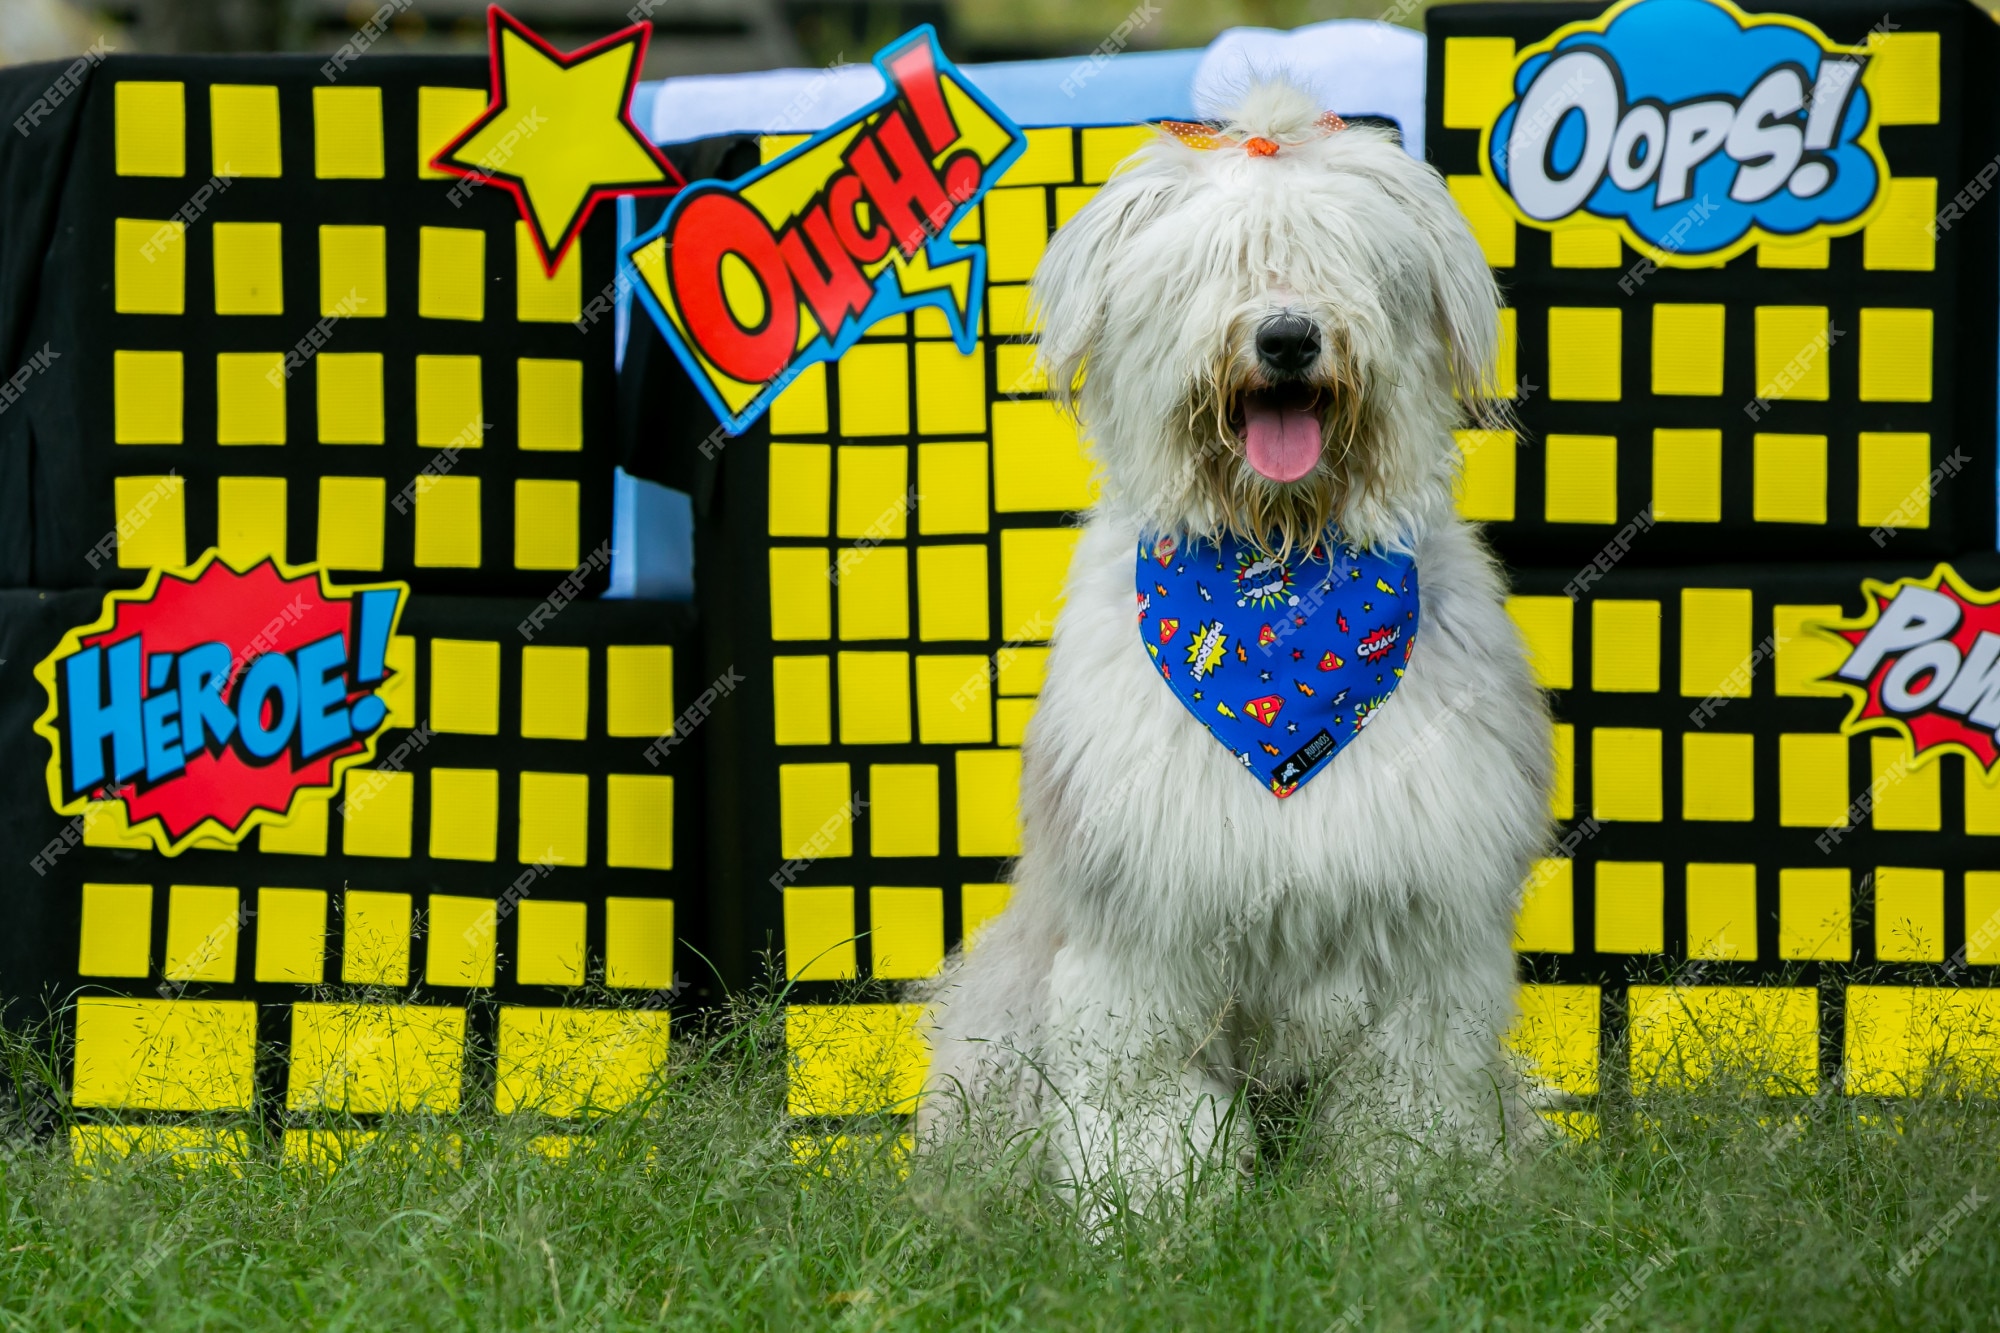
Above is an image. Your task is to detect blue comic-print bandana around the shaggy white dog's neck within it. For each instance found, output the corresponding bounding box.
[1134,536,1418,799]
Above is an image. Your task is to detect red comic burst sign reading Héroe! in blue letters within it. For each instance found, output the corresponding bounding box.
[34,552,410,857]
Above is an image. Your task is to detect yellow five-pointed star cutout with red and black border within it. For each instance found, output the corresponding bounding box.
[432,6,682,274]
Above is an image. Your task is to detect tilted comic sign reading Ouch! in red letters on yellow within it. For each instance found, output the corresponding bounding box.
[624,26,1028,432]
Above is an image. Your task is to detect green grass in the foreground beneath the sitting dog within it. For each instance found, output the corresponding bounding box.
[0,992,2000,1333]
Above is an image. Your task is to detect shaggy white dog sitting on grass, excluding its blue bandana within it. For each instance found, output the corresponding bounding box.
[918,82,1552,1199]
